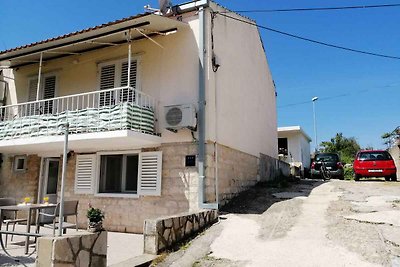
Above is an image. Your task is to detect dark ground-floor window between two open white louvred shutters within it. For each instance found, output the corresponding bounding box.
[99,154,139,194]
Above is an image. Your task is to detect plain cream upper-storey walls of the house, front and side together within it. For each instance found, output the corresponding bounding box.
[6,4,277,158]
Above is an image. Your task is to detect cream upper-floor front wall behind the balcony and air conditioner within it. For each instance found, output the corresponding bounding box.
[11,17,199,146]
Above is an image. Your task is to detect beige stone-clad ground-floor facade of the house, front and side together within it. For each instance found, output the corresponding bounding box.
[0,142,282,233]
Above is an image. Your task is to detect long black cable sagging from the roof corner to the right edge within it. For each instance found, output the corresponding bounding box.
[218,12,400,60]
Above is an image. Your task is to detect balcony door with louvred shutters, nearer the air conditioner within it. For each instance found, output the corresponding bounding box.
[99,58,140,106]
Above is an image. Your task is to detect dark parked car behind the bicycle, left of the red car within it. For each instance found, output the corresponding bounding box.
[311,153,344,180]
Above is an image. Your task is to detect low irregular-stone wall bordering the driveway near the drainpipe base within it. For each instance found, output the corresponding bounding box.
[144,210,218,254]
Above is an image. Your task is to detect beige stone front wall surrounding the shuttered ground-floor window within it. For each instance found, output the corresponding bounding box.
[65,143,198,233]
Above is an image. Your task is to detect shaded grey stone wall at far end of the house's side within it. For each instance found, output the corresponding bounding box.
[259,154,291,182]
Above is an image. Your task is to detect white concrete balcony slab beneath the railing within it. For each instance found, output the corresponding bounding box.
[0,130,161,156]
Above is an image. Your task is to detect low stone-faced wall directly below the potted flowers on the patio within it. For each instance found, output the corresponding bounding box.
[36,231,107,267]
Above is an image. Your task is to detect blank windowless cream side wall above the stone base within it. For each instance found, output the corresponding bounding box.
[206,3,278,158]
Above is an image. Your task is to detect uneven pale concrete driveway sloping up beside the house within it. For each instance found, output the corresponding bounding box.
[159,180,400,266]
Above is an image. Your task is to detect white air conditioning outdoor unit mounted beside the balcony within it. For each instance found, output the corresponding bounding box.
[164,104,197,131]
